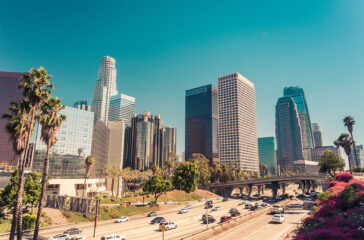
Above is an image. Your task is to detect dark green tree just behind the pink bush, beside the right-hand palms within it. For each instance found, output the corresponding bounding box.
[319,151,345,177]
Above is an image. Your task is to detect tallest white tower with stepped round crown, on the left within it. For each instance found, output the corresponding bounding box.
[92,56,118,125]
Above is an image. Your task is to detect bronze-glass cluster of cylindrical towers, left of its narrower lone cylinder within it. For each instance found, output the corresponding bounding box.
[125,112,162,170]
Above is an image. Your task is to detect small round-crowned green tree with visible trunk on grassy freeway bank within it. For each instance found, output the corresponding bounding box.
[143,175,172,204]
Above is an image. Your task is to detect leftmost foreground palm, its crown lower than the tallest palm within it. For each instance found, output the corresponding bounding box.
[3,100,32,239]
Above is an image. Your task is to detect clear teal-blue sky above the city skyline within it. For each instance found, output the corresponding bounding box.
[0,0,364,159]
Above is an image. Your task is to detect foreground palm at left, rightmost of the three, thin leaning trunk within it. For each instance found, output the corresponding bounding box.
[33,97,66,240]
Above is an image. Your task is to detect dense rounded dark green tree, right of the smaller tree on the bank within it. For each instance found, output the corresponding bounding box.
[173,161,200,193]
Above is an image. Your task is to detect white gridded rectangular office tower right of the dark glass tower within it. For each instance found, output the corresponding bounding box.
[218,72,259,172]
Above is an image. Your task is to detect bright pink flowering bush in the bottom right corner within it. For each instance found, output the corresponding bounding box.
[295,173,364,240]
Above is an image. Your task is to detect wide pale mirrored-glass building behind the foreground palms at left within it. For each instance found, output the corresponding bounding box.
[33,107,94,179]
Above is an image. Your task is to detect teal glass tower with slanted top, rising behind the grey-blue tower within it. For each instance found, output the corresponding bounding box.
[283,87,315,160]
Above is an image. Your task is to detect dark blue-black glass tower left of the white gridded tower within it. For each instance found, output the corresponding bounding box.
[185,84,219,161]
